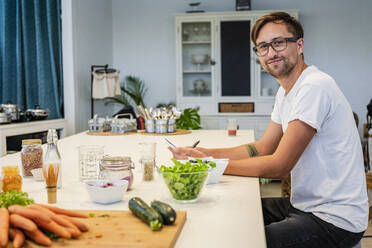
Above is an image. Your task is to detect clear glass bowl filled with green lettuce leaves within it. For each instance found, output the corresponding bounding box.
[159,159,216,203]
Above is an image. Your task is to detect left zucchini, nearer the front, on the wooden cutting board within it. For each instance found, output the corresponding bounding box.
[128,197,163,231]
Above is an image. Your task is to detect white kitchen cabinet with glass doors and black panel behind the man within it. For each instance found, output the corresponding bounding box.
[175,10,299,139]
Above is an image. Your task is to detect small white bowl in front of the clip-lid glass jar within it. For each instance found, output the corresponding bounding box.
[85,180,128,204]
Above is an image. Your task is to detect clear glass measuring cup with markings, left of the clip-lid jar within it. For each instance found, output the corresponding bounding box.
[78,145,104,181]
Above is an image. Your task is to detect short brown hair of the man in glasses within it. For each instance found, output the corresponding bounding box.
[251,12,304,45]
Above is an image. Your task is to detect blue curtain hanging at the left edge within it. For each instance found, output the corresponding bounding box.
[0,0,63,119]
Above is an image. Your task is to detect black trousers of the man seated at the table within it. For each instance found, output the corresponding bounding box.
[262,198,364,248]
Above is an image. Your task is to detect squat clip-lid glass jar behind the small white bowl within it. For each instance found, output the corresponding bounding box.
[99,156,134,189]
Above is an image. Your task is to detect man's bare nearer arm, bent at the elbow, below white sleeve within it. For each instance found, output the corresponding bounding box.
[225,120,316,178]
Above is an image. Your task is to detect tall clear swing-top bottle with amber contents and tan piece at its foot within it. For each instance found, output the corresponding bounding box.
[43,129,62,203]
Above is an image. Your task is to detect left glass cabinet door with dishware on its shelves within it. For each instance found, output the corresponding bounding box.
[181,22,212,97]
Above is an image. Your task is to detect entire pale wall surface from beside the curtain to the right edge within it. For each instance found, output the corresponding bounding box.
[63,0,372,135]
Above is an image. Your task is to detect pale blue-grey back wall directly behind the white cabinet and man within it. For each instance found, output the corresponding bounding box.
[112,0,372,135]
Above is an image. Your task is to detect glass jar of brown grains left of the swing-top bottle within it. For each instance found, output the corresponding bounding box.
[21,139,43,177]
